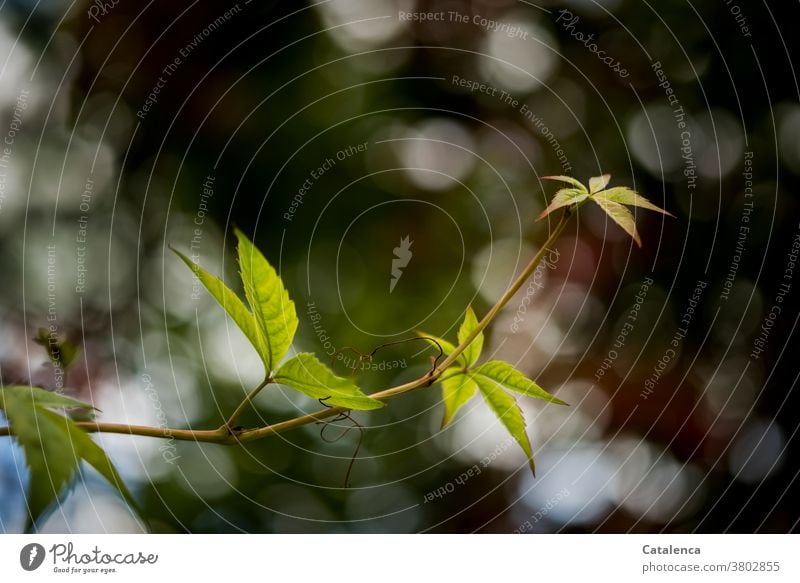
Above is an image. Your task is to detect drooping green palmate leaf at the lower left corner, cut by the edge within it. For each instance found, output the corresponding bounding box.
[0,386,136,529]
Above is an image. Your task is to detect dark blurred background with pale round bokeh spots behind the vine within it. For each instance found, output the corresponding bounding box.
[0,0,800,533]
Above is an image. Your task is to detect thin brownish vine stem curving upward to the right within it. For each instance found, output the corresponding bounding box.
[0,209,572,445]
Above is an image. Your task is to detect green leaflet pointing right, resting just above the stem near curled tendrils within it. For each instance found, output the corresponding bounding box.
[273,352,384,410]
